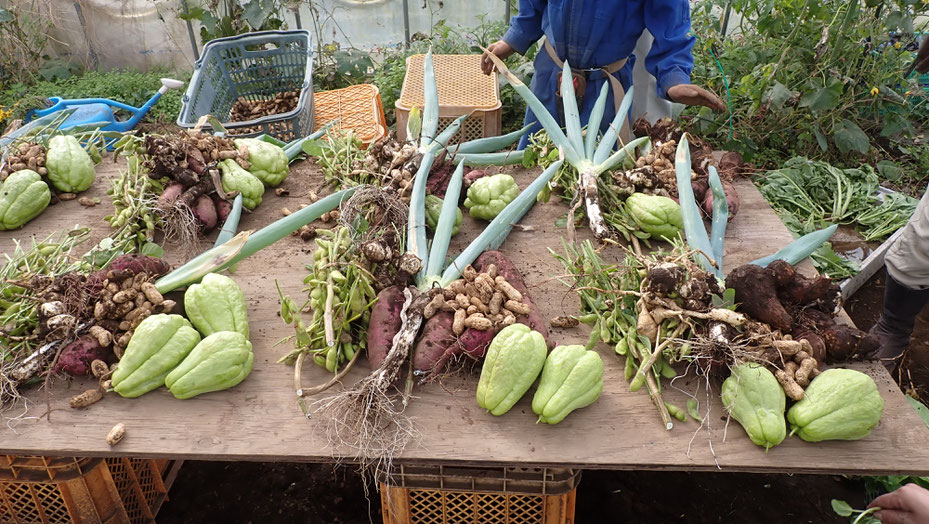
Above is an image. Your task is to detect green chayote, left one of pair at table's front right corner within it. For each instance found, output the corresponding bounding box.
[722,362,787,451]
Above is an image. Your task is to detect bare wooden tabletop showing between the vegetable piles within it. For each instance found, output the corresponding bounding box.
[0,161,929,475]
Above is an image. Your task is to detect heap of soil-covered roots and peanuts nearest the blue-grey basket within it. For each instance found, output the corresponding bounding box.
[145,130,250,233]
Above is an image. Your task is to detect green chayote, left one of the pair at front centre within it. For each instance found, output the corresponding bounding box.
[477,324,548,416]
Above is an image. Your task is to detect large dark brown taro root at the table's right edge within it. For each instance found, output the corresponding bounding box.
[726,260,879,362]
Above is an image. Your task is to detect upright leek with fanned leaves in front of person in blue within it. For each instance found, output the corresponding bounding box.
[482,48,648,238]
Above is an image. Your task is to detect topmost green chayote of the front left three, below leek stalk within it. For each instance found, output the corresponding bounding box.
[184,273,248,338]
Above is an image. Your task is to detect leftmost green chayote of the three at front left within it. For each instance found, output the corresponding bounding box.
[111,315,200,398]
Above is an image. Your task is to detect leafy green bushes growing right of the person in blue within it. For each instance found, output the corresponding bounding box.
[685,0,929,165]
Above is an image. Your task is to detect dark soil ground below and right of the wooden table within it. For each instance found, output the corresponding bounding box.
[158,272,929,524]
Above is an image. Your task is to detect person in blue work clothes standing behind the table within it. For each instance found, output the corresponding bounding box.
[482,0,726,149]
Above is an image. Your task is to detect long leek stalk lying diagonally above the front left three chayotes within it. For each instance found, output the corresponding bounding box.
[155,188,356,294]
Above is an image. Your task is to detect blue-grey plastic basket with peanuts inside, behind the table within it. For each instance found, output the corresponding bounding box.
[177,30,314,142]
